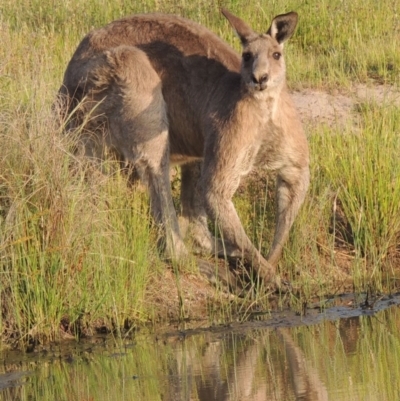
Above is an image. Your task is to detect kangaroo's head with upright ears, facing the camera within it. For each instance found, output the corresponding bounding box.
[221,9,298,92]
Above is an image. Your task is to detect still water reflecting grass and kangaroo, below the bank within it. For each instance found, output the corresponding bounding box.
[0,299,400,401]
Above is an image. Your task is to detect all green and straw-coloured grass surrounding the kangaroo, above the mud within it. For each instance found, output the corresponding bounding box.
[0,0,400,344]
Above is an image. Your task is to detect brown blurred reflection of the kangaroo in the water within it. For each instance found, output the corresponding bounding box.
[164,328,328,401]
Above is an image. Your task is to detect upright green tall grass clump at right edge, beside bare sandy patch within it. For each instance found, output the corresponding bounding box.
[320,103,400,290]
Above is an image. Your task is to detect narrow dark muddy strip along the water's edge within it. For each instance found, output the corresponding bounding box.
[0,292,400,354]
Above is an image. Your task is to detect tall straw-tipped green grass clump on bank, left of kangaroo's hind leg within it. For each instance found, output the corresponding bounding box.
[0,98,160,346]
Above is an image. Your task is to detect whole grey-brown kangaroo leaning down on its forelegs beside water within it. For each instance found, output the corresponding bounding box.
[60,9,309,284]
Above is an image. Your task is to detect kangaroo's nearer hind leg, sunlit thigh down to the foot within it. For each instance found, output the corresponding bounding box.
[106,46,187,259]
